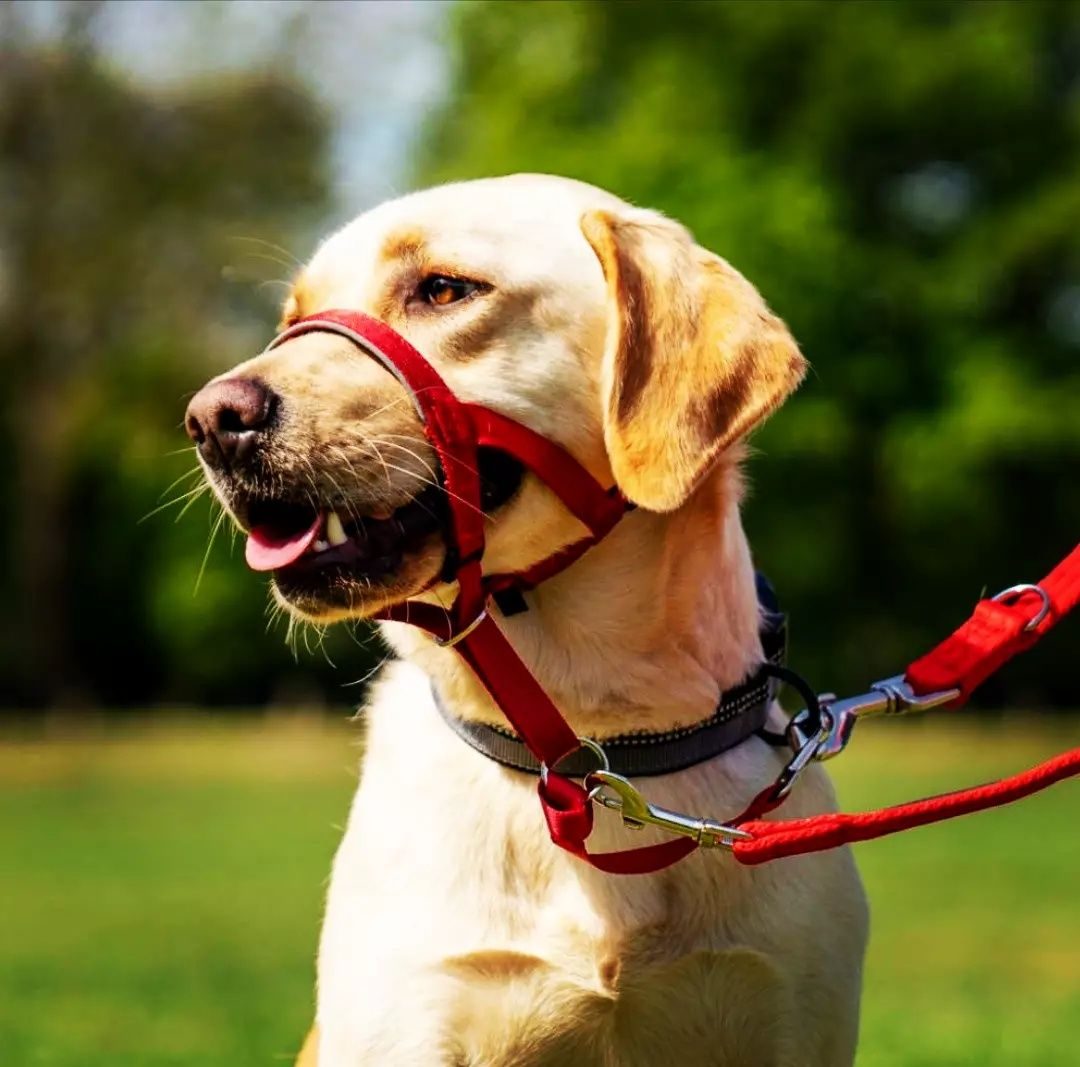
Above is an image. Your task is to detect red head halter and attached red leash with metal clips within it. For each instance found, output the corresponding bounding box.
[270,310,1080,874]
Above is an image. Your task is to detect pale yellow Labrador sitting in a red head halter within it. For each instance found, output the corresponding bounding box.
[187,175,867,1067]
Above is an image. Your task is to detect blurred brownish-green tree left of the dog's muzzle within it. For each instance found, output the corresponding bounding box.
[0,3,380,704]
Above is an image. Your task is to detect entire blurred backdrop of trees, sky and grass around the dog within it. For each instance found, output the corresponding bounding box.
[0,0,1080,1067]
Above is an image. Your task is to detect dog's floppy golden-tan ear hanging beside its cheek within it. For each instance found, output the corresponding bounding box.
[581,210,807,511]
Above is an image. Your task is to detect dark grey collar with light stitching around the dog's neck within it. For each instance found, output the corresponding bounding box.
[432,575,787,778]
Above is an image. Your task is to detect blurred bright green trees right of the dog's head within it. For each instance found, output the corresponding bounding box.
[419,0,1080,706]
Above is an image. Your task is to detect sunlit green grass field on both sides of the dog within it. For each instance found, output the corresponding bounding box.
[0,714,1080,1067]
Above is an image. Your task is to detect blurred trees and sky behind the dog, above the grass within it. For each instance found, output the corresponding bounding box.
[0,0,1080,708]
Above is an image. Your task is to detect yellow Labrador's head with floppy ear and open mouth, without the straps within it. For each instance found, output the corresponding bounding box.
[187,175,805,620]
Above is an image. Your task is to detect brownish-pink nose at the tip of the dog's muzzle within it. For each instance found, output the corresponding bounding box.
[184,378,278,467]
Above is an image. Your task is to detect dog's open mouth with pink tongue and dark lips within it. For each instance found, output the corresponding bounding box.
[232,448,524,616]
